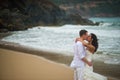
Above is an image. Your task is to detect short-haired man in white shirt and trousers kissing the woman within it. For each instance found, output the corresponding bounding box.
[71,30,92,80]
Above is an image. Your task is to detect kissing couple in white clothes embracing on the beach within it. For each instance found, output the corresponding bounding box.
[70,30,107,80]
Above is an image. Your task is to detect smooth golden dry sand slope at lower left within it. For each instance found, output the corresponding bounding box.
[0,49,73,80]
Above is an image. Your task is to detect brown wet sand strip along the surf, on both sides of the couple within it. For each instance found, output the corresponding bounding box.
[0,33,120,80]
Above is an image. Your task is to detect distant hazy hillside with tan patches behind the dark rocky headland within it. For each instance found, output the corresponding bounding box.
[50,0,120,17]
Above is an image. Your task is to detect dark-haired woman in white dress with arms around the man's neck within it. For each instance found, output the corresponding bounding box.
[76,33,107,80]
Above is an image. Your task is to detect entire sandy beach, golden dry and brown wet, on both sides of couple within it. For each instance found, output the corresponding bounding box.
[0,33,120,80]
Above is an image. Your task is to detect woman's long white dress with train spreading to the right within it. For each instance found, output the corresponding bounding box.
[83,50,107,80]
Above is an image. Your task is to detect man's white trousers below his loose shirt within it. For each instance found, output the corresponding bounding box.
[74,68,84,80]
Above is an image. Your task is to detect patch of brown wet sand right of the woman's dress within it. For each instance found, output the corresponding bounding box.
[93,60,120,80]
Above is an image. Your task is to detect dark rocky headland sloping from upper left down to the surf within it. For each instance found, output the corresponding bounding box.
[0,0,94,31]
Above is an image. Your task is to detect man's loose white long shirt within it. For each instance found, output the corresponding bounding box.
[70,41,86,68]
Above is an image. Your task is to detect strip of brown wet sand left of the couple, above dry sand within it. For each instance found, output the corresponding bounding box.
[0,41,73,65]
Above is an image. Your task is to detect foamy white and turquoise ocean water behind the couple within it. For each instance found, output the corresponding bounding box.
[2,18,120,64]
